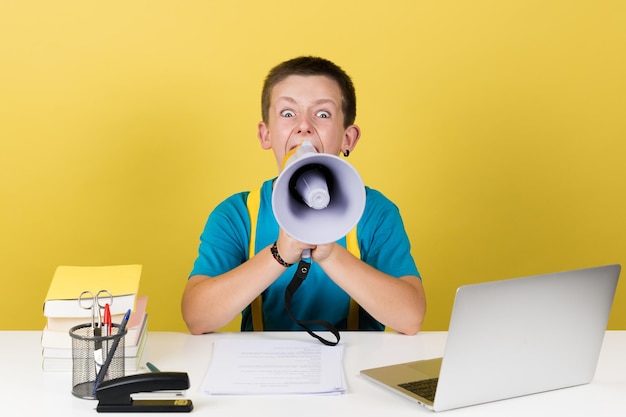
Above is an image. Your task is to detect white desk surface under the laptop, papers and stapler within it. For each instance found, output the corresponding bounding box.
[0,331,626,417]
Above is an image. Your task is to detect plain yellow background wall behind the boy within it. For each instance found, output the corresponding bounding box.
[0,0,626,331]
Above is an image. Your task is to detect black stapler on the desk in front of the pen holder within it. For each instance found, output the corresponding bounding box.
[96,372,193,413]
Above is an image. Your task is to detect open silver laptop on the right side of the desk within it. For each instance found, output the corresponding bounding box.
[361,265,621,411]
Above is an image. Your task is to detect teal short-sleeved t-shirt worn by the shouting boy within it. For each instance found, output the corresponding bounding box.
[189,180,419,330]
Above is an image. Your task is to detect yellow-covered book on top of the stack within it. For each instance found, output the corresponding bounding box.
[43,265,142,318]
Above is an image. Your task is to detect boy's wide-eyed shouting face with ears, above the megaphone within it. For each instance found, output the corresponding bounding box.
[258,75,360,171]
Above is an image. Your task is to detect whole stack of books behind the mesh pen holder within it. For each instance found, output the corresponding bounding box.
[41,265,148,372]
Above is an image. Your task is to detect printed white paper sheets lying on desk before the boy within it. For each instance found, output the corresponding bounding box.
[202,339,346,395]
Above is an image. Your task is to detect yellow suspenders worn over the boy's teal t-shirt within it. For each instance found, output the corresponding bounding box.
[247,189,361,331]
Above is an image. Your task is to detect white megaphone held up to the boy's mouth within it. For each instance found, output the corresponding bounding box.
[272,141,365,245]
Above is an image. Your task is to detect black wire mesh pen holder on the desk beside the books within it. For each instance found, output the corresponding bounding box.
[70,324,126,400]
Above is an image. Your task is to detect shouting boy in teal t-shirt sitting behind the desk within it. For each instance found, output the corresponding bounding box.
[182,57,426,334]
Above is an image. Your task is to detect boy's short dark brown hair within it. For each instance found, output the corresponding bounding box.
[261,56,356,127]
